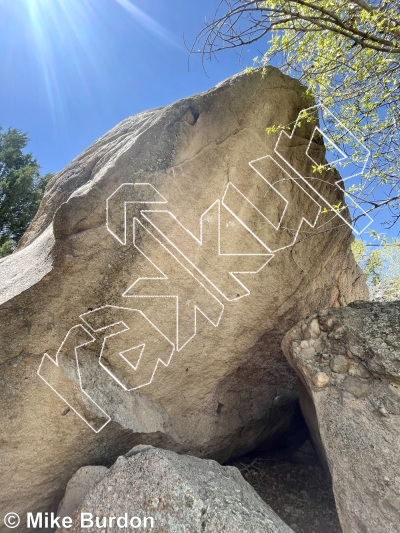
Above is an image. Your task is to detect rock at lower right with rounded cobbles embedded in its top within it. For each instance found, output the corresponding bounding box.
[282,302,400,533]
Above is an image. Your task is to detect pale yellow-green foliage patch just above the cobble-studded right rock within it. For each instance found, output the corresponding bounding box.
[352,239,400,301]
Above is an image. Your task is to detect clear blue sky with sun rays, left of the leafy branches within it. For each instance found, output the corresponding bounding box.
[0,0,255,173]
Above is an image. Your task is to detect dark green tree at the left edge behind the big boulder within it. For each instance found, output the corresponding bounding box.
[0,127,52,257]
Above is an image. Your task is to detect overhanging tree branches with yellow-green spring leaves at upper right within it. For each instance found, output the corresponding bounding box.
[198,0,400,228]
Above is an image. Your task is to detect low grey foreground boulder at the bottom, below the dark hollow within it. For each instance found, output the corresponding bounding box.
[58,446,293,533]
